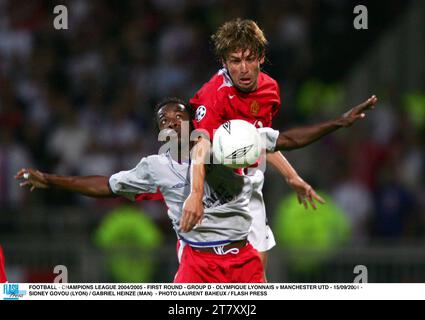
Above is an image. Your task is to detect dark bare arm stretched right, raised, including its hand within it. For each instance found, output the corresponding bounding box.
[276,95,378,150]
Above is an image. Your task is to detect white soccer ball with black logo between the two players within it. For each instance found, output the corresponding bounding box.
[213,120,261,169]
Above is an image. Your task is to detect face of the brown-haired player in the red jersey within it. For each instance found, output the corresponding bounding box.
[223,49,264,93]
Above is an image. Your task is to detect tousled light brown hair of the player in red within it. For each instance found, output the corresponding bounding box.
[211,18,267,61]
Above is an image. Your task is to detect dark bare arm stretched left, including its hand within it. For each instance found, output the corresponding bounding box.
[15,169,115,198]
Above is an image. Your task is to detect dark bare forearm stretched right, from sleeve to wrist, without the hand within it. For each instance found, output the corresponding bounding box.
[276,118,343,150]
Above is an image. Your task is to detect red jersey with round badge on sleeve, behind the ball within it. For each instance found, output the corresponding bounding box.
[190,69,280,138]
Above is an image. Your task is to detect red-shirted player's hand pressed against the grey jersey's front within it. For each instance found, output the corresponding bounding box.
[180,193,204,232]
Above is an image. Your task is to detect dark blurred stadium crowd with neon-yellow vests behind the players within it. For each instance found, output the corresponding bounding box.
[0,0,425,282]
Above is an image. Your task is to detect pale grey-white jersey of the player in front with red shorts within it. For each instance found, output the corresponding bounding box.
[109,128,279,247]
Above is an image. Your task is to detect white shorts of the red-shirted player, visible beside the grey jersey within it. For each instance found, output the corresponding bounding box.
[247,169,276,252]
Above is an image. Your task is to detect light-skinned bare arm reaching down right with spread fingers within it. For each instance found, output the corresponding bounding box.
[267,151,325,209]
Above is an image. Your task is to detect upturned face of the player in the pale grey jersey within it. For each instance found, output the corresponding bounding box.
[157,102,190,139]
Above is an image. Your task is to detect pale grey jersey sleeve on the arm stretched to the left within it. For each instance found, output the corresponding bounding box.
[109,158,157,201]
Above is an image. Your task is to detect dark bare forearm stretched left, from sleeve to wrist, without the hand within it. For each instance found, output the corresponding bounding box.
[43,173,115,198]
